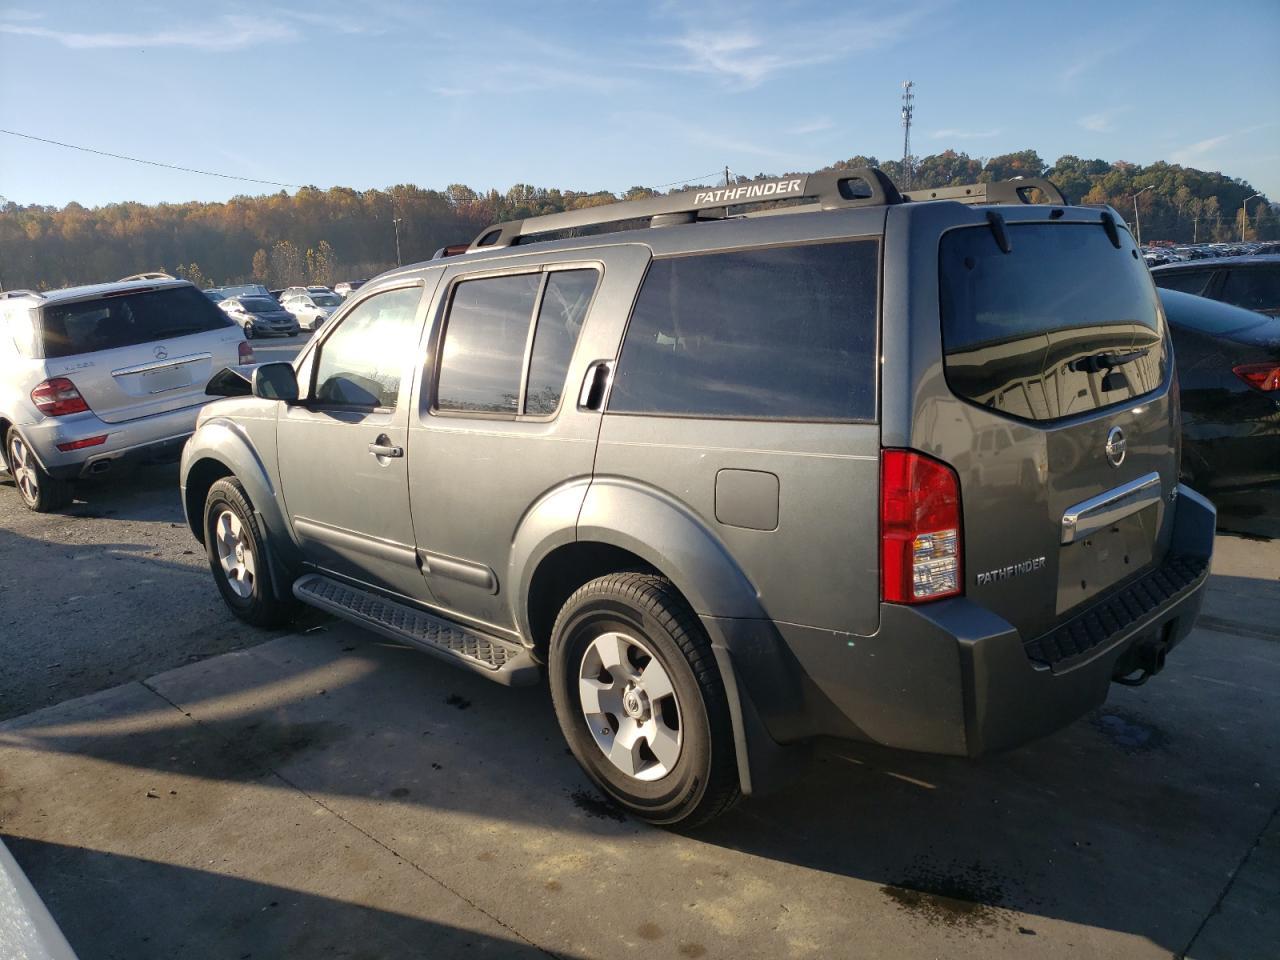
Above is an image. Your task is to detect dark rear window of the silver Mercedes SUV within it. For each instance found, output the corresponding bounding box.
[40,287,236,357]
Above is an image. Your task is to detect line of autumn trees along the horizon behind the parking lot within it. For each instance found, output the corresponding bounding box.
[0,150,1280,289]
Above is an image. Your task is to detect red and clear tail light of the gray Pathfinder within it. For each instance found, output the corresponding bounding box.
[881,451,963,603]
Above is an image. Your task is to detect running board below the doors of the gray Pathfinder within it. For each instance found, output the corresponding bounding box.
[293,573,540,686]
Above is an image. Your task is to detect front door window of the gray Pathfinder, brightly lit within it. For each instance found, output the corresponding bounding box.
[315,287,422,407]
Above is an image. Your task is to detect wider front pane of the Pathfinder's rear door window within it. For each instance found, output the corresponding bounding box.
[435,274,541,413]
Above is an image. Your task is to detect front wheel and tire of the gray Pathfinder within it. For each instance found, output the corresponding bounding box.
[205,477,296,627]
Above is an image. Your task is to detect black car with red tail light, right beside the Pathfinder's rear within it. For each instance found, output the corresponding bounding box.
[1160,289,1280,527]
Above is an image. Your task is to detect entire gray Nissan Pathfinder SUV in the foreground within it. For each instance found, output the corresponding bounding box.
[182,169,1215,824]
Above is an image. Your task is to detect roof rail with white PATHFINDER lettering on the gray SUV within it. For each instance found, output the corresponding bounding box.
[467,166,902,251]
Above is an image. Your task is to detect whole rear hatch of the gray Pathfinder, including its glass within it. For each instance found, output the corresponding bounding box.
[925,211,1178,640]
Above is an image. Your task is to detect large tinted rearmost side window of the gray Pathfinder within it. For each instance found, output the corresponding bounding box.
[609,241,879,420]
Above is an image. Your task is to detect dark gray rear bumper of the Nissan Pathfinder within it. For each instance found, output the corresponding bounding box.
[708,486,1215,756]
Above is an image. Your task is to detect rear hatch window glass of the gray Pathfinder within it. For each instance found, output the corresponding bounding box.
[940,223,1166,421]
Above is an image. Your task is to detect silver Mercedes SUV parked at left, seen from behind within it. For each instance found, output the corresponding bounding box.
[0,280,253,512]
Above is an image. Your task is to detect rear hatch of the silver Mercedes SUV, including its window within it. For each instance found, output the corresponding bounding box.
[37,285,244,424]
